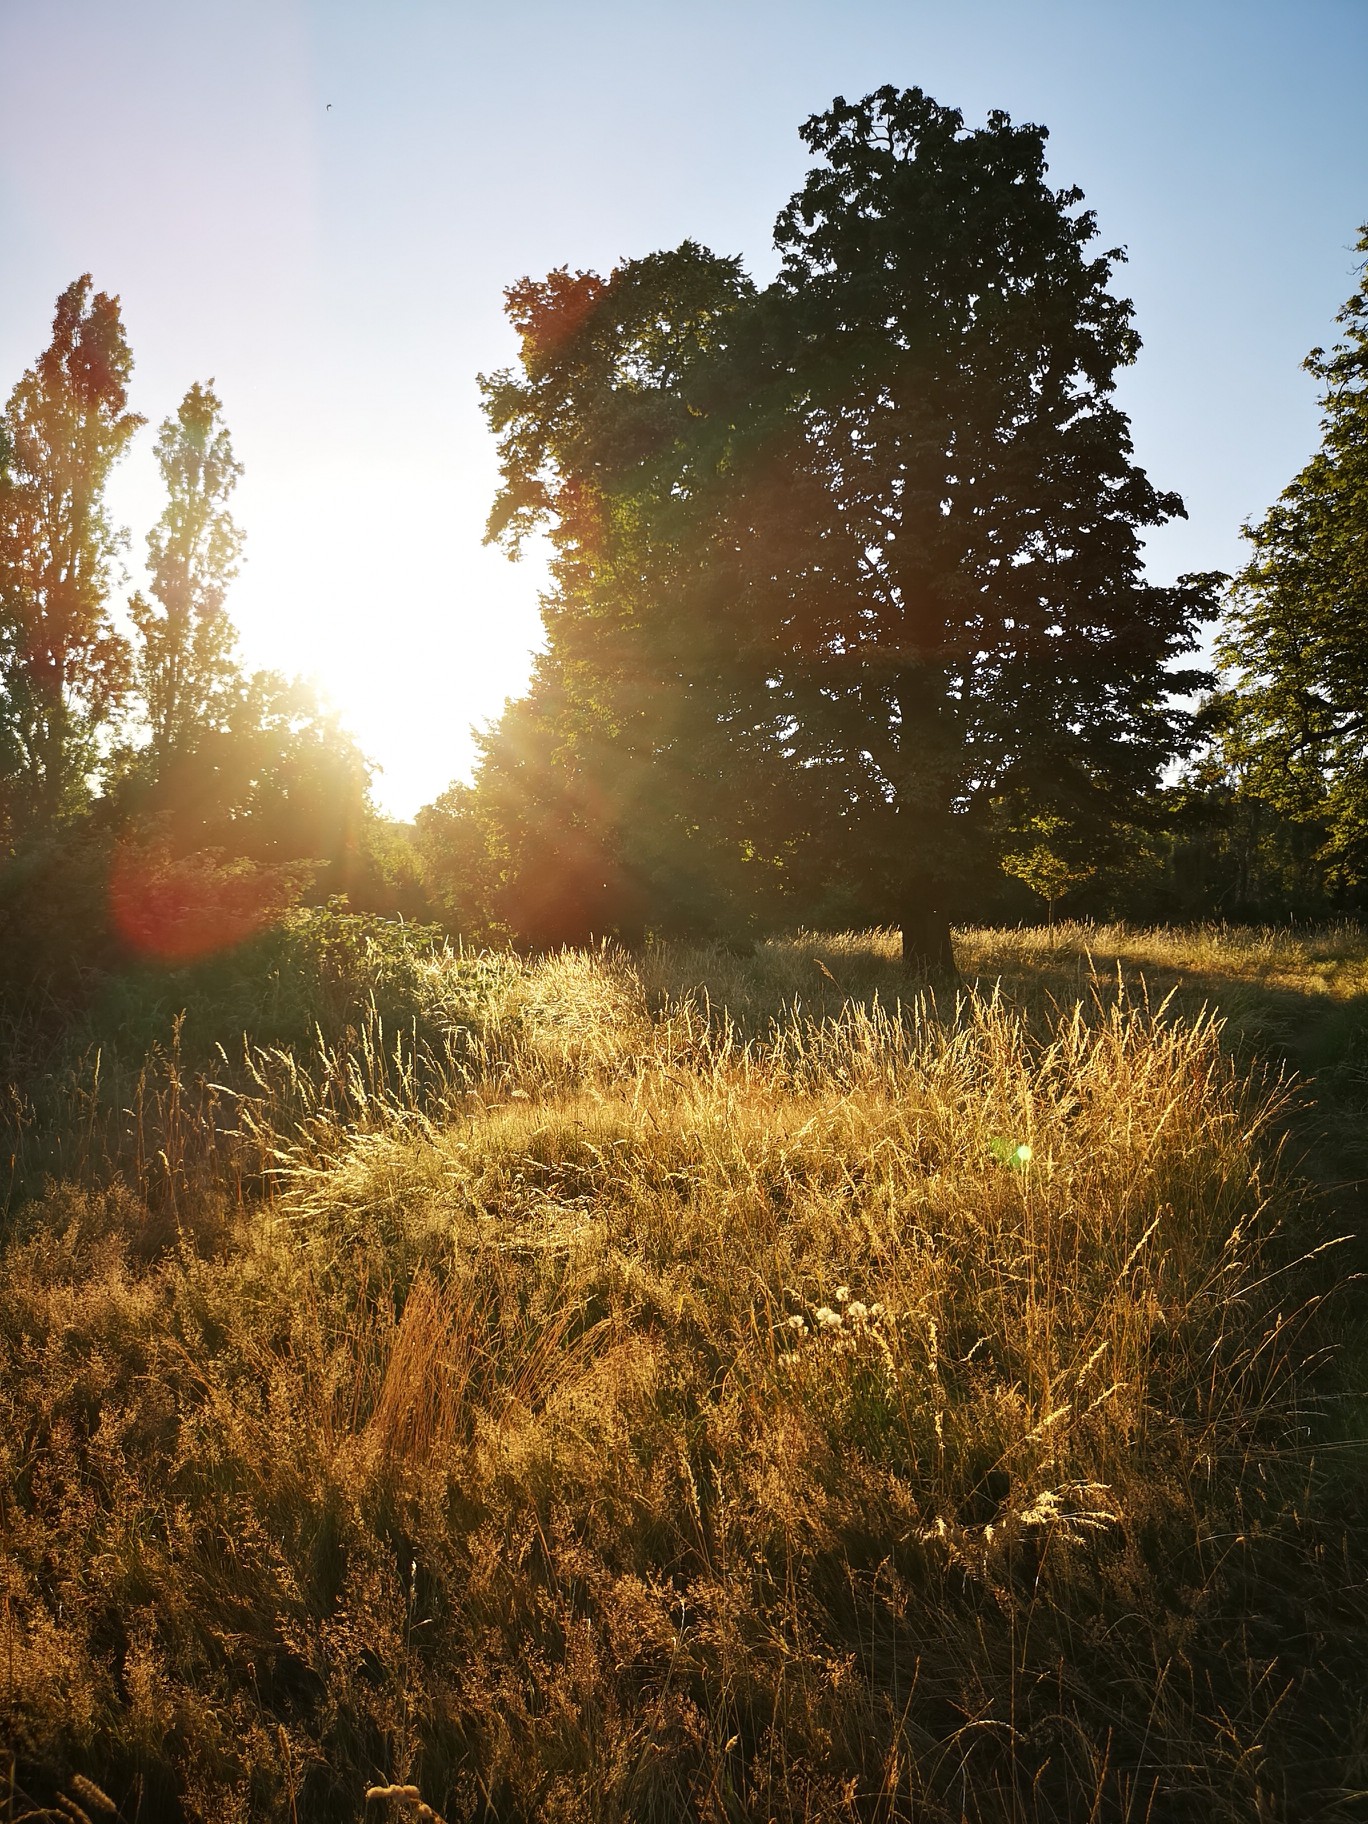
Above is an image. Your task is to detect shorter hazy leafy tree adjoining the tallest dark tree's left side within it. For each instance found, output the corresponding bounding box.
[481,243,802,943]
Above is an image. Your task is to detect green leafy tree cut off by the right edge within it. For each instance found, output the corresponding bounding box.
[1215,226,1368,886]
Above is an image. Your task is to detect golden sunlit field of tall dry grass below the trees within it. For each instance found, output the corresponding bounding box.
[0,927,1368,1824]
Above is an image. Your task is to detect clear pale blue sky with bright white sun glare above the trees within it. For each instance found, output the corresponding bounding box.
[0,0,1368,817]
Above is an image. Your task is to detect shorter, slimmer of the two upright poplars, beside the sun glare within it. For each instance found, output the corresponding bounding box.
[130,381,243,766]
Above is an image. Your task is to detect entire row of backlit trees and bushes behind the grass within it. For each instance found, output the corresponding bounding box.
[0,88,1368,994]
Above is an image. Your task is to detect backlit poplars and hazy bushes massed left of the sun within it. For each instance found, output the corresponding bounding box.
[0,275,423,1007]
